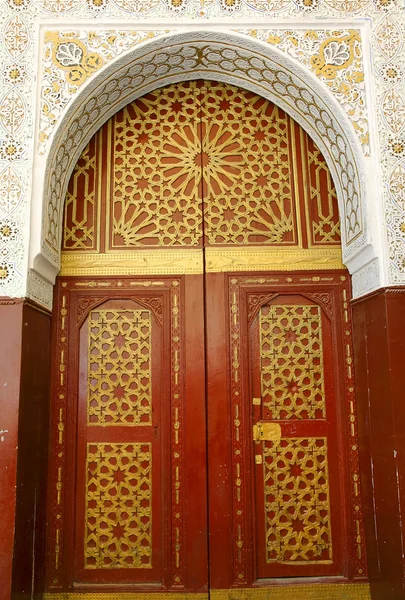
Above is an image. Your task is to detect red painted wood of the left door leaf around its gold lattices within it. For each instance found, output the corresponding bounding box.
[48,276,208,591]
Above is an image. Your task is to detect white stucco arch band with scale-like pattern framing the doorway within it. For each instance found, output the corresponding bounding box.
[28,29,380,305]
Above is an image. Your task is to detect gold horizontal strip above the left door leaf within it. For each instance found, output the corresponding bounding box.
[59,249,204,276]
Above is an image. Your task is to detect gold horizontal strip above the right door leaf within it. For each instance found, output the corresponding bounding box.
[205,246,345,273]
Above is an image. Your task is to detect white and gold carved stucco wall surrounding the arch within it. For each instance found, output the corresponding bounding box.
[0,0,405,304]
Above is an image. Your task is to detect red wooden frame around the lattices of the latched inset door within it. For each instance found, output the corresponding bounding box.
[250,287,340,579]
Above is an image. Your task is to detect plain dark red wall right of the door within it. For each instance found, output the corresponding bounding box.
[353,288,405,600]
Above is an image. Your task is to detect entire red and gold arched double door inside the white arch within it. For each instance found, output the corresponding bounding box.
[43,82,367,598]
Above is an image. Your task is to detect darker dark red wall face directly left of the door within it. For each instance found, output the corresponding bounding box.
[12,303,51,600]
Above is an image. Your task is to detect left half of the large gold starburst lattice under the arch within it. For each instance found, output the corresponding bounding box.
[106,82,202,250]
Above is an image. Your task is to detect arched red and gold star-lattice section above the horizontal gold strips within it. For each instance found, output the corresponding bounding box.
[64,81,340,254]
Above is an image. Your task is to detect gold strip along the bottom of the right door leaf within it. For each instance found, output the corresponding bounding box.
[210,583,371,600]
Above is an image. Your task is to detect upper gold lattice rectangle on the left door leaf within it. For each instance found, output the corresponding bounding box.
[87,309,152,426]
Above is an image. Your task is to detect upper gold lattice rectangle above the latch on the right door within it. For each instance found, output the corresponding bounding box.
[260,305,325,419]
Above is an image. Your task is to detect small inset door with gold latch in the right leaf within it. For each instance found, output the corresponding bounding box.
[250,294,342,578]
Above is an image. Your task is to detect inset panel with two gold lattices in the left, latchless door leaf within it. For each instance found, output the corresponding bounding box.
[75,298,164,582]
